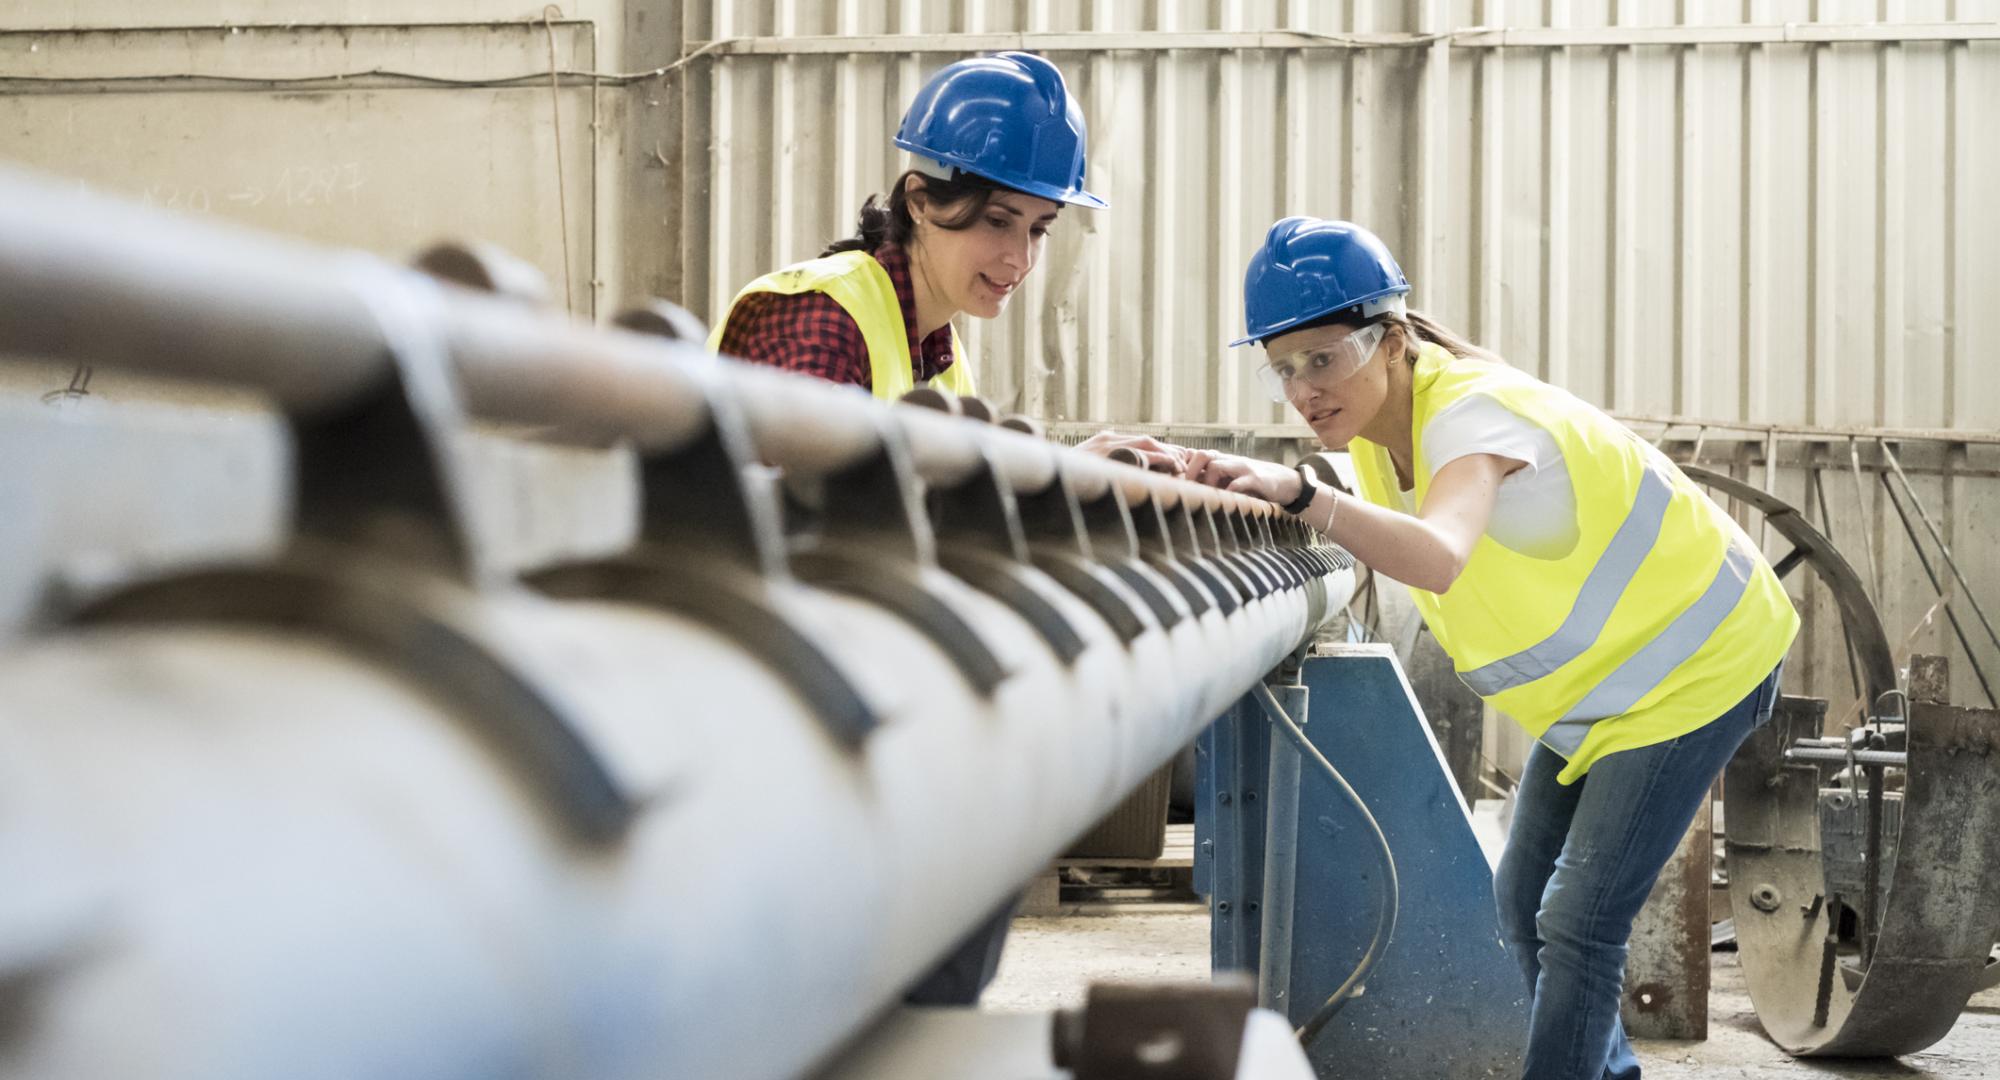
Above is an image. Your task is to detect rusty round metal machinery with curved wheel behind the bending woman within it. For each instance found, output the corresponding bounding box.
[1682,466,2000,1056]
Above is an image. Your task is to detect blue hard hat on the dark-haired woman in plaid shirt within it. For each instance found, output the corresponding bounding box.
[896,52,1106,210]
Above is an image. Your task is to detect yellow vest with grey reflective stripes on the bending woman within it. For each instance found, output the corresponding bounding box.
[1350,344,1798,784]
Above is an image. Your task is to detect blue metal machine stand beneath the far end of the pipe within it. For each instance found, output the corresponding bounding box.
[1194,646,1528,1080]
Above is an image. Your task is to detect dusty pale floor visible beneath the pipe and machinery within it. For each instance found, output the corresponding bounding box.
[980,904,2000,1080]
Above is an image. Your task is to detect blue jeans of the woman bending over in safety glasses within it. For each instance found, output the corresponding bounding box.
[1494,670,1778,1080]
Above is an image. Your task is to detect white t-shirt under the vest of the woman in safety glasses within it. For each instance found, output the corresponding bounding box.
[1398,394,1578,558]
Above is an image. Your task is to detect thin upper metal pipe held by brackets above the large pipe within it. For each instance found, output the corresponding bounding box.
[0,170,1272,532]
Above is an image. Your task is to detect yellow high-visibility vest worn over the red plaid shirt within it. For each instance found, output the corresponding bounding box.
[708,252,974,402]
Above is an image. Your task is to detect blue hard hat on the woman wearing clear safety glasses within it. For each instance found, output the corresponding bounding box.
[1230,218,1410,346]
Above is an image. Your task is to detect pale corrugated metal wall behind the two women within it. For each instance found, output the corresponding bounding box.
[678,0,2000,708]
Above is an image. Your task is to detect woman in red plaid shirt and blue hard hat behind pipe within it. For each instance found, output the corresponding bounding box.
[710,52,1104,400]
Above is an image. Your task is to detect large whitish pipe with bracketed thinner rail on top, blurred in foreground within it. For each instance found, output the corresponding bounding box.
[0,169,1352,1078]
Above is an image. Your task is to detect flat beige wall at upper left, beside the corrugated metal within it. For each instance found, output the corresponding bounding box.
[0,0,696,316]
